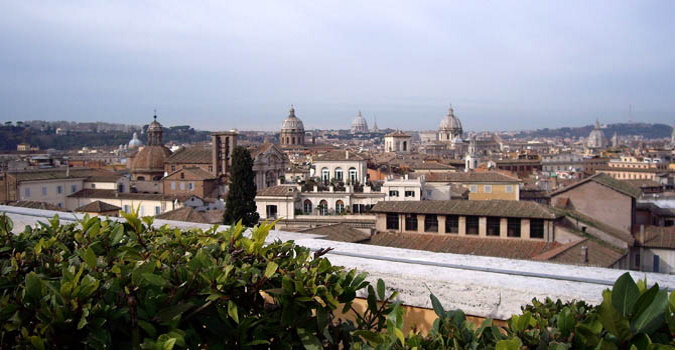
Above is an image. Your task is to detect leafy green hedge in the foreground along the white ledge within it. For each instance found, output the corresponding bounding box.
[0,213,675,349]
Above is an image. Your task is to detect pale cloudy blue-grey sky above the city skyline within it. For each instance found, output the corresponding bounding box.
[0,0,675,131]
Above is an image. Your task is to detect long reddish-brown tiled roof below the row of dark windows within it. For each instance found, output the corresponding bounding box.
[368,232,560,259]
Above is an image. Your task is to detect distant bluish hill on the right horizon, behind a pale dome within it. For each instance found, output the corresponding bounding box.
[514,123,673,139]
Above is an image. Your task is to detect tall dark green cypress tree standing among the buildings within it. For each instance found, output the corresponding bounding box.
[223,146,260,227]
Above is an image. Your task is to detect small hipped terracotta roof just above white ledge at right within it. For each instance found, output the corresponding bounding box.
[534,239,628,267]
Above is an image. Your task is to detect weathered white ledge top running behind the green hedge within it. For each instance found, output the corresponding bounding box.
[0,206,675,319]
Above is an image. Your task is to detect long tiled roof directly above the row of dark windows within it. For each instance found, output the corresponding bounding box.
[370,200,556,219]
